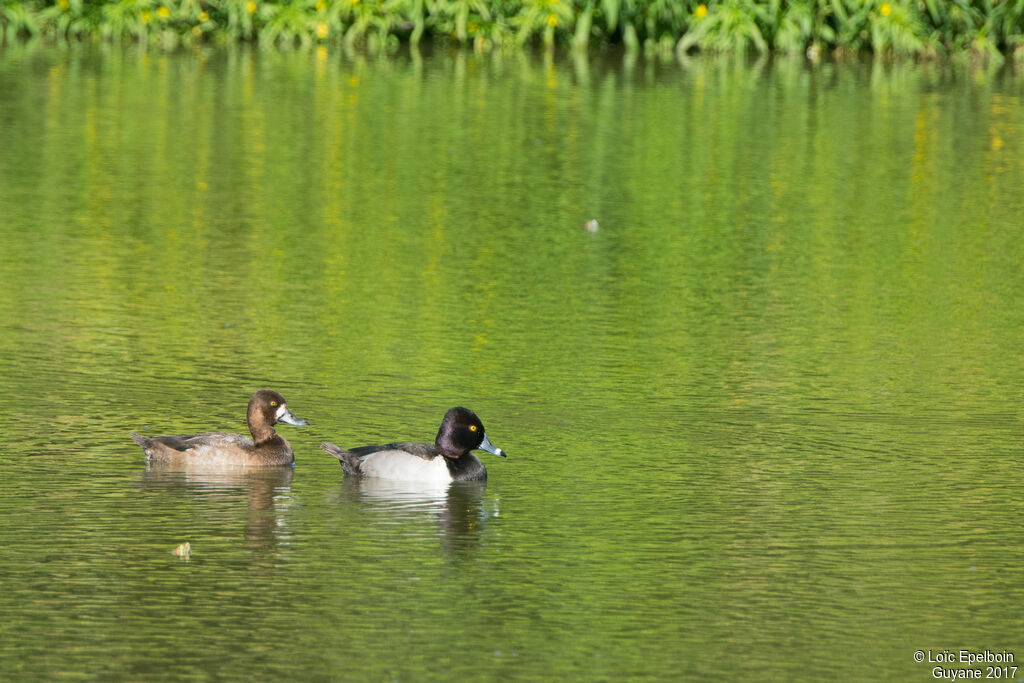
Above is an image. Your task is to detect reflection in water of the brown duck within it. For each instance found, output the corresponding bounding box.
[142,463,295,548]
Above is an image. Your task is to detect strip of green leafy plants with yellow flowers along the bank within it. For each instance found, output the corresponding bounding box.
[0,0,1024,59]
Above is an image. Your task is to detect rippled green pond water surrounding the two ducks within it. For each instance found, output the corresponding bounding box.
[0,47,1024,681]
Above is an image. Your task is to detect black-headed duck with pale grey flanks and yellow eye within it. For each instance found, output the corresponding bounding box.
[321,407,508,483]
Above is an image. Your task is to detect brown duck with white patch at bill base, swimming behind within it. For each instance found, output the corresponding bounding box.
[131,389,309,467]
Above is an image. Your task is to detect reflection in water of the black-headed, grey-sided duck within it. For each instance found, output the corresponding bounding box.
[339,476,498,552]
